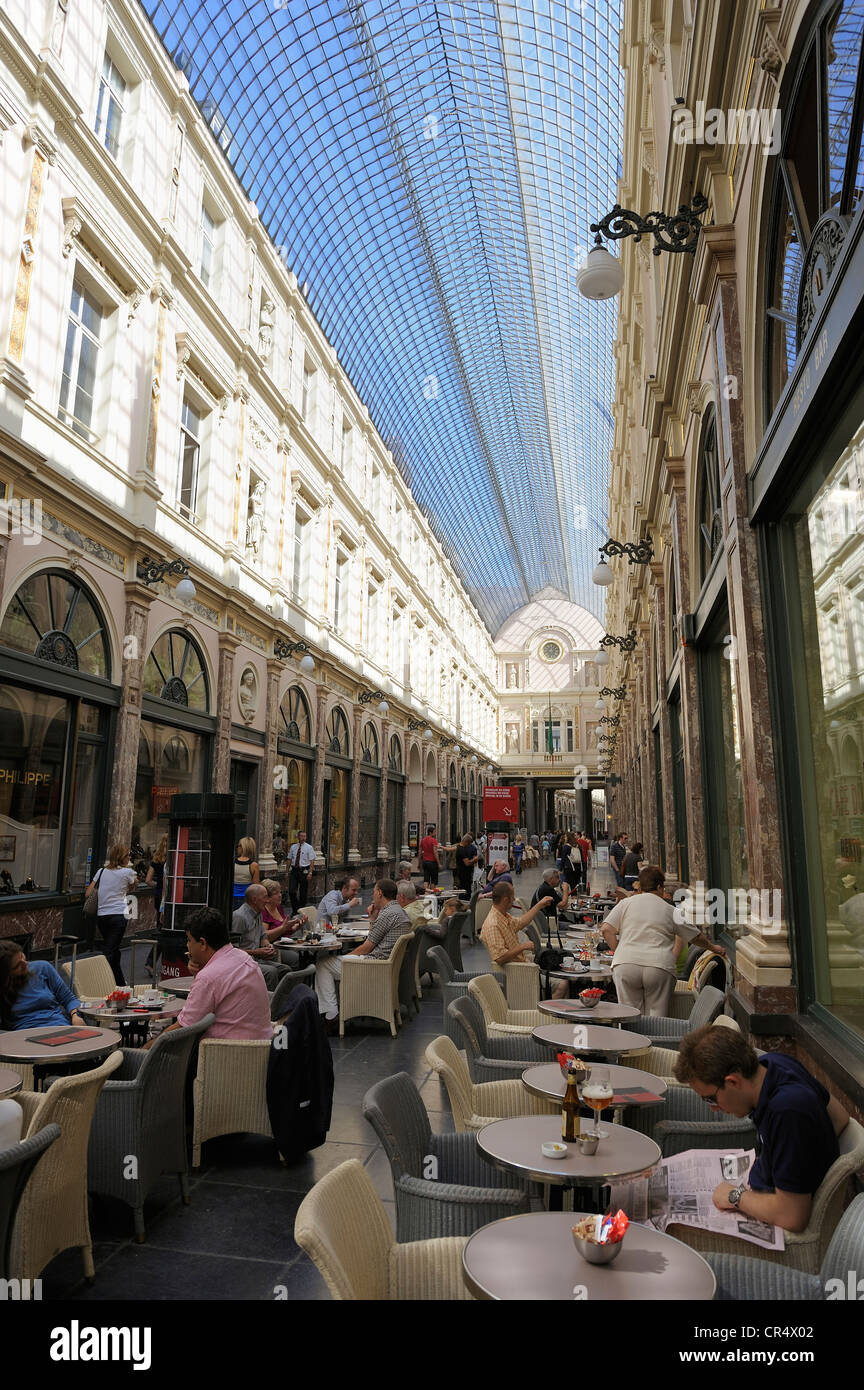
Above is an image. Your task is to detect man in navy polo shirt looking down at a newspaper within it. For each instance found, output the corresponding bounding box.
[675,1026,849,1232]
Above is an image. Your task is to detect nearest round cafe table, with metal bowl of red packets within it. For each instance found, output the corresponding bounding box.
[463,1212,717,1305]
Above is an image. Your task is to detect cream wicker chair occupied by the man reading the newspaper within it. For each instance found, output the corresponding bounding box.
[668,1119,864,1275]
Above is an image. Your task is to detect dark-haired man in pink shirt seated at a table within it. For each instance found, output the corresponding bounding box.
[147,908,274,1045]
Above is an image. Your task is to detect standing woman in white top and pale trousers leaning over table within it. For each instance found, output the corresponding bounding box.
[601,865,725,1017]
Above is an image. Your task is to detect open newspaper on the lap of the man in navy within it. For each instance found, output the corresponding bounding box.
[611,1148,785,1251]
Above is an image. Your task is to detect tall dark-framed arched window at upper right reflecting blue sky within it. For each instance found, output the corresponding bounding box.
[765,4,864,418]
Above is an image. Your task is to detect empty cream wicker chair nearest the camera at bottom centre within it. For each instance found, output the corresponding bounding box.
[294,1158,471,1302]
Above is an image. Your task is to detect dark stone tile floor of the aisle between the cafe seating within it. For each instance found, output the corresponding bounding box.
[42,869,602,1302]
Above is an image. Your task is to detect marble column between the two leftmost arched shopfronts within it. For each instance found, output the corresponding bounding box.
[108,580,156,845]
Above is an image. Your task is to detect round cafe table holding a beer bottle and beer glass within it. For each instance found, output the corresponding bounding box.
[476,1115,660,1211]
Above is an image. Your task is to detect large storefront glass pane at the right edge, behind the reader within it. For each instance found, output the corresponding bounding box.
[796,425,864,1034]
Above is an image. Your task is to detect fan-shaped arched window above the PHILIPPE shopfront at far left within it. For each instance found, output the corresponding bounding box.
[0,570,111,680]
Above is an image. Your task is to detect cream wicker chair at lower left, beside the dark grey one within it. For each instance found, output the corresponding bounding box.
[10,1049,122,1279]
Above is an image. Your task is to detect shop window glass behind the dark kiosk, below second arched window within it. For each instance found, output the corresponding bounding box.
[132,719,210,862]
